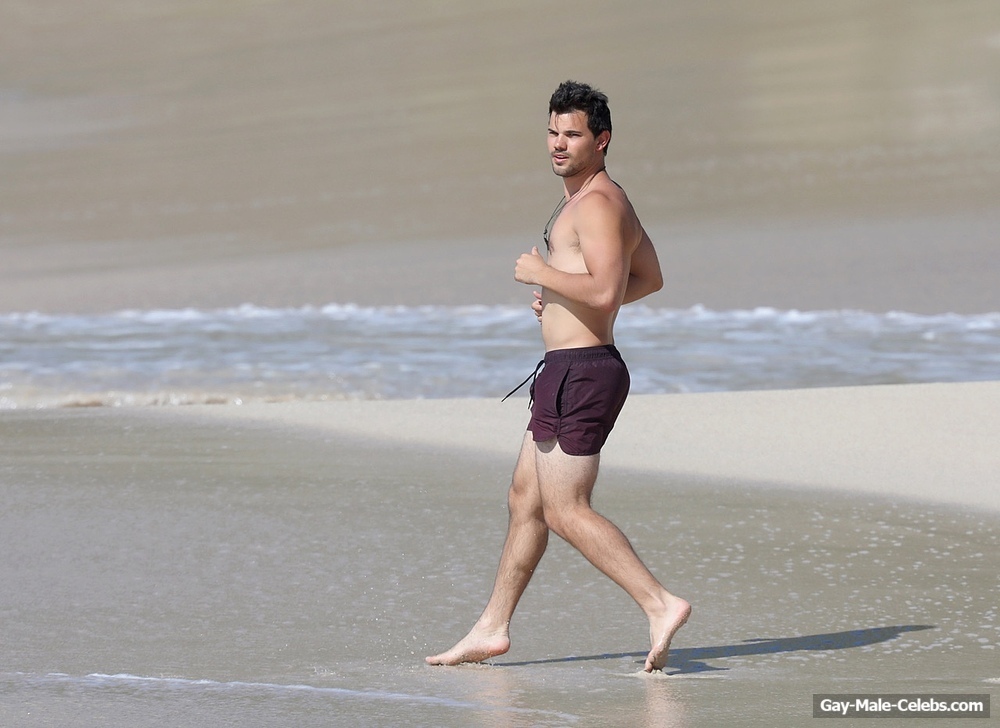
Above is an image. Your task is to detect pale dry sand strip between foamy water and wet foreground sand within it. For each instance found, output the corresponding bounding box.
[184,382,1000,511]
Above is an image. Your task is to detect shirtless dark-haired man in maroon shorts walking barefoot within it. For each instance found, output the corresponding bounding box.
[427,81,691,672]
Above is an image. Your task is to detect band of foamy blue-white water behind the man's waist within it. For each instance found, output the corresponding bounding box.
[0,305,1000,409]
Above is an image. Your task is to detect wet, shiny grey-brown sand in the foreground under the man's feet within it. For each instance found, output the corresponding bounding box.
[0,408,1000,728]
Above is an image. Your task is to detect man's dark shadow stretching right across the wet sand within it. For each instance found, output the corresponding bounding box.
[504,624,934,674]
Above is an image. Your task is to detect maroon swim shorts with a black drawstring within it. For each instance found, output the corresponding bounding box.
[528,346,629,455]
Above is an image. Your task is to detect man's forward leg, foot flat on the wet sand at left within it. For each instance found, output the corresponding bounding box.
[426,432,549,665]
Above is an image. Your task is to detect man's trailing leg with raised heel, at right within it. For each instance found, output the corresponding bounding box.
[535,440,691,672]
